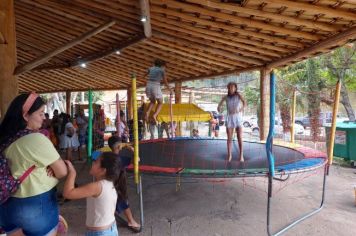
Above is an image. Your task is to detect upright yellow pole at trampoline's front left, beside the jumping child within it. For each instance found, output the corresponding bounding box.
[131,74,139,184]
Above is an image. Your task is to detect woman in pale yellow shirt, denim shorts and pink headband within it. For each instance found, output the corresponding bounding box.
[0,93,67,236]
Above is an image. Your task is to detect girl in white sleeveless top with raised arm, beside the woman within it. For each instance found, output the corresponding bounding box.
[63,152,127,236]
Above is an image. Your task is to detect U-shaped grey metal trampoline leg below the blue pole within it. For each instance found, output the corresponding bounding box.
[267,166,327,235]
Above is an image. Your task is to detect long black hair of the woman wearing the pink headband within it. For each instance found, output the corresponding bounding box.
[0,93,45,144]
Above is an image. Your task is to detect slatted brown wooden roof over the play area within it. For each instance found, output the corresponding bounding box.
[15,0,356,92]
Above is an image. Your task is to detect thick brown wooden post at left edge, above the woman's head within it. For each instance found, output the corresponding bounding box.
[0,0,18,119]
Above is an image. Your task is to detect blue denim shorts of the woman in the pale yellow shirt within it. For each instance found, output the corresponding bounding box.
[0,188,59,236]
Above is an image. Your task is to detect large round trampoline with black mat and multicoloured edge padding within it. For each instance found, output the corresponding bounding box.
[129,138,327,178]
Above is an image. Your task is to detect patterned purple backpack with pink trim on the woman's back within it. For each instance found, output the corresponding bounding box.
[0,129,36,204]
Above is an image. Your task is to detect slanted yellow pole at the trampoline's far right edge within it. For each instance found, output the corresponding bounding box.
[328,80,341,167]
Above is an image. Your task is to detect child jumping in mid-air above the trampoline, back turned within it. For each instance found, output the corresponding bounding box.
[144,59,172,122]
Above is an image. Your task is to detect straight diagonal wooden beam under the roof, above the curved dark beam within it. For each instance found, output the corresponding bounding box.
[15,21,115,75]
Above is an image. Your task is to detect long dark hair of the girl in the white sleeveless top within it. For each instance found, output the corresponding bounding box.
[100,152,128,201]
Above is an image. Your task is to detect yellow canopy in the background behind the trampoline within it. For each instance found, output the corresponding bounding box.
[145,103,211,122]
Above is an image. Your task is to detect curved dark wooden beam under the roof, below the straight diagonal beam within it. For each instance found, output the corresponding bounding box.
[36,35,145,70]
